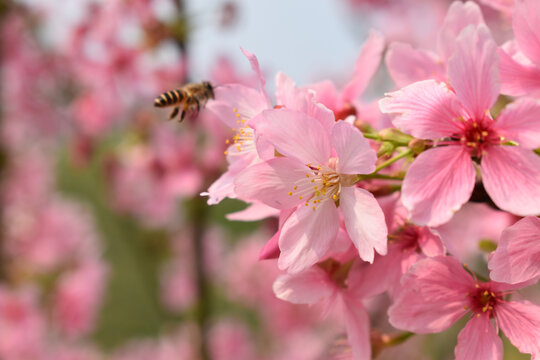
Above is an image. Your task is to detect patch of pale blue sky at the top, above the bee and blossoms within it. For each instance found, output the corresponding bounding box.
[187,0,368,89]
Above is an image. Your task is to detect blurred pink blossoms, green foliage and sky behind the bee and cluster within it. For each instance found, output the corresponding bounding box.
[0,0,525,360]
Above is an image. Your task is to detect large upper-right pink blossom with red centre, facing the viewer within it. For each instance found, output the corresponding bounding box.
[379,25,540,226]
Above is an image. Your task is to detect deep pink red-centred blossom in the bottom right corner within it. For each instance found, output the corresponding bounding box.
[388,256,540,360]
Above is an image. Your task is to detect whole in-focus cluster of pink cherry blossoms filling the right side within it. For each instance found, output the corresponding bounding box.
[204,0,540,360]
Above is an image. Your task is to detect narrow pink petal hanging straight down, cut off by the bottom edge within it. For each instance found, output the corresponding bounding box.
[343,295,371,360]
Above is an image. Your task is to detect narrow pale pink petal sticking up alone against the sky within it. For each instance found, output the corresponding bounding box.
[341,30,384,102]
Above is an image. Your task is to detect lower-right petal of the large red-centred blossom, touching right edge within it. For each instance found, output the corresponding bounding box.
[481,146,540,216]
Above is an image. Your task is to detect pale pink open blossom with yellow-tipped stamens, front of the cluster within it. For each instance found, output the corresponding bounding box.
[235,109,387,272]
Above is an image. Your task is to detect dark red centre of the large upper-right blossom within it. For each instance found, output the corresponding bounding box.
[455,118,502,158]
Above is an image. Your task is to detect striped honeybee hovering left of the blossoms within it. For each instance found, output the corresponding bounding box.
[154,81,214,122]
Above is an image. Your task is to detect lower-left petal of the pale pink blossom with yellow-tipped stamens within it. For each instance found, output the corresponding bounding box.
[278,200,339,274]
